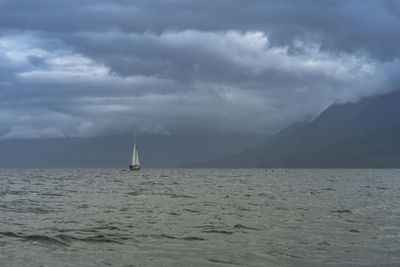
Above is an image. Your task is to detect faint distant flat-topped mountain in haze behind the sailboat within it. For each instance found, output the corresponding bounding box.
[0,134,266,168]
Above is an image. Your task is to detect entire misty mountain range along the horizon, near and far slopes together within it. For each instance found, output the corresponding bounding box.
[0,91,400,168]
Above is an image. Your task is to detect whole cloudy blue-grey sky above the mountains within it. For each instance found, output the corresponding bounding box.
[0,0,400,139]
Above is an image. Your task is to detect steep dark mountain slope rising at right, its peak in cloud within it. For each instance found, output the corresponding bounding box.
[182,90,400,168]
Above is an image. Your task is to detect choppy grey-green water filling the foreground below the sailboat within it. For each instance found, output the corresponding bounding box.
[0,169,400,266]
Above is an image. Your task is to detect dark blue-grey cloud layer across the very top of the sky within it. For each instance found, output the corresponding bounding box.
[0,0,400,58]
